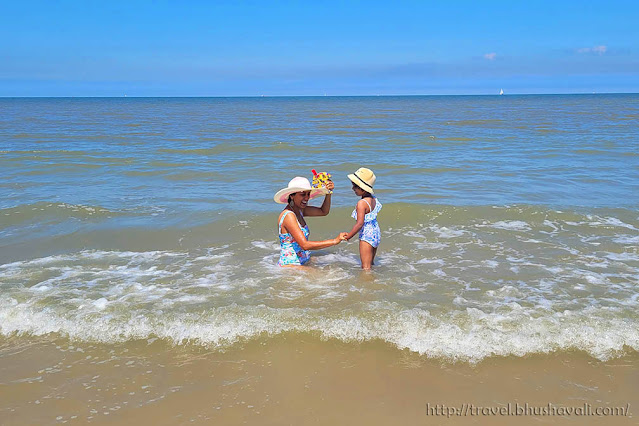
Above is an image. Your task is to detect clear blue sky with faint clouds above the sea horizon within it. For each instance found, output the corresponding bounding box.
[0,0,639,96]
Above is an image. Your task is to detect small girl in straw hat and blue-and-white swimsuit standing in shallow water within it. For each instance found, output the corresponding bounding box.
[346,167,382,269]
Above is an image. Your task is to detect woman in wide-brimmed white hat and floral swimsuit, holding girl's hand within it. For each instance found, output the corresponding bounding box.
[273,176,347,266]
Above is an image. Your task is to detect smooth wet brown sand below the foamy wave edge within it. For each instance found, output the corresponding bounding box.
[0,333,639,425]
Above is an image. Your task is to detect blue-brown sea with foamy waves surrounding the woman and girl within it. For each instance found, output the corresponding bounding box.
[0,95,639,361]
